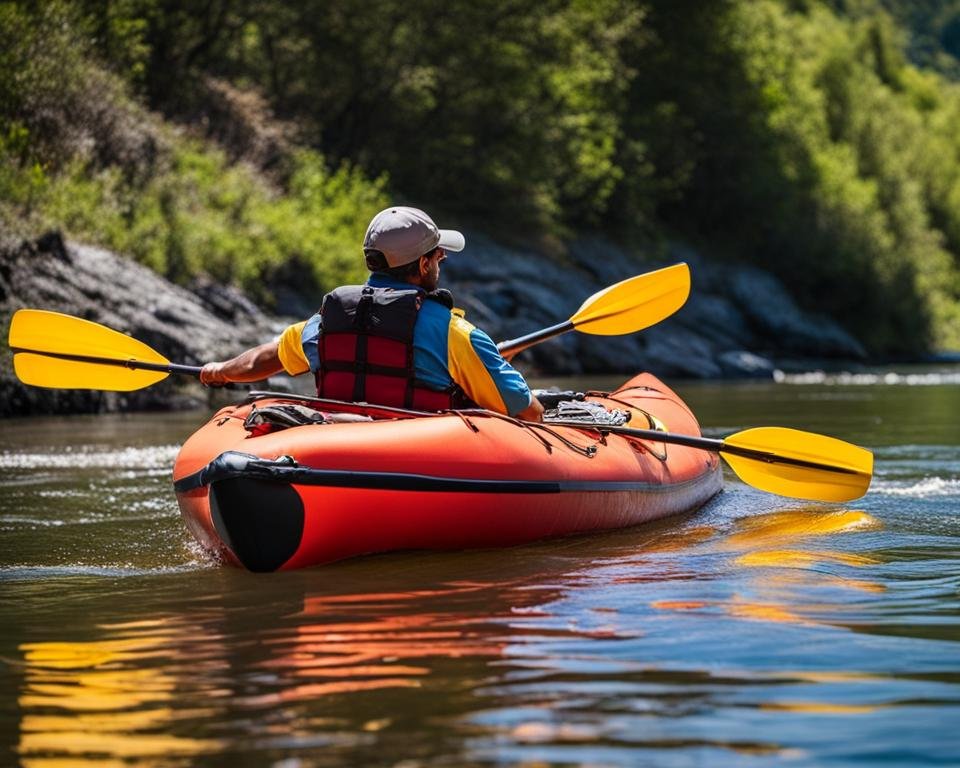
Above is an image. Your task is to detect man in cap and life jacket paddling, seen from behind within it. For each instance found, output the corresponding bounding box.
[200,206,543,421]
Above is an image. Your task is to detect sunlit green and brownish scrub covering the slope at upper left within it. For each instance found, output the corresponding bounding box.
[0,3,388,302]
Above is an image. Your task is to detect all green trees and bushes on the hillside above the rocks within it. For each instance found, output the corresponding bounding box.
[0,0,960,355]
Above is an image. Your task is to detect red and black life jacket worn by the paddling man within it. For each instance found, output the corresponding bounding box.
[316,285,473,411]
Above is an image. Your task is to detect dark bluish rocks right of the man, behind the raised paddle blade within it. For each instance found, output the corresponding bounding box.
[444,232,864,378]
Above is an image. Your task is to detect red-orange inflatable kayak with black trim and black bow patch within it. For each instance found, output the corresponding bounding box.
[174,374,721,571]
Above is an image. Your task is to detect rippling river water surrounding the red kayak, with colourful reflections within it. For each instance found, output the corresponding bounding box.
[0,368,960,768]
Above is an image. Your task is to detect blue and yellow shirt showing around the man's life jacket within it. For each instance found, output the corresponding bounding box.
[279,274,531,416]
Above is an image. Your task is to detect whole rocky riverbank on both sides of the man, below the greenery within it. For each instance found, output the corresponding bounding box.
[0,230,866,416]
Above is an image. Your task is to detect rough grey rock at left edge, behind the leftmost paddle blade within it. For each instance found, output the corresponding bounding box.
[0,232,284,415]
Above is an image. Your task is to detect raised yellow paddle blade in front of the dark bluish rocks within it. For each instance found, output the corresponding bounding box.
[570,264,690,336]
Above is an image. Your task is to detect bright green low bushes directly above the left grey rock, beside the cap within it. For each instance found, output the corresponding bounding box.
[0,140,388,303]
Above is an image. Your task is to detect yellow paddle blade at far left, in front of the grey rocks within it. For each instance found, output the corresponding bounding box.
[9,309,169,392]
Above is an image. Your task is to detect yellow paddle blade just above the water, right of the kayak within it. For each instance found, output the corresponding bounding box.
[720,427,873,501]
